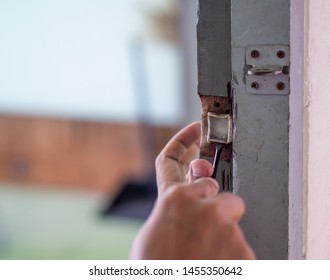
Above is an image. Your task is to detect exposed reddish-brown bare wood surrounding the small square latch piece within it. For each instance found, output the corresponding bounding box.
[198,93,232,162]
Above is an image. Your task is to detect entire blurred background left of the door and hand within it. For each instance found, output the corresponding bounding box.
[0,0,199,259]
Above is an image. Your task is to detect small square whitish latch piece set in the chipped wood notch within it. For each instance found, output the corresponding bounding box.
[207,112,233,144]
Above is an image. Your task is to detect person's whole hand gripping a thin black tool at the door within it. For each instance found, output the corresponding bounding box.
[130,123,255,259]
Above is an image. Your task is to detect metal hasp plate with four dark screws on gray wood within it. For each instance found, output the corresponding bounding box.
[245,45,290,95]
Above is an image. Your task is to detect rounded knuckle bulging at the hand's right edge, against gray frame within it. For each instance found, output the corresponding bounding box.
[217,192,245,222]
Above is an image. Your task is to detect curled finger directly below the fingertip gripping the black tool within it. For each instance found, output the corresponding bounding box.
[186,178,219,198]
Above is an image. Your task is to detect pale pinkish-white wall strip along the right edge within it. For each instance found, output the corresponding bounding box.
[304,0,330,259]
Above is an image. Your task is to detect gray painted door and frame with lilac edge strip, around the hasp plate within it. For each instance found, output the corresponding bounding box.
[197,0,304,259]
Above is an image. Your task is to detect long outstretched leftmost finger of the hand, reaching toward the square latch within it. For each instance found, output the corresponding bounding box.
[156,122,201,192]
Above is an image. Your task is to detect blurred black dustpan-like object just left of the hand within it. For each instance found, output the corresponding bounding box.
[102,175,157,220]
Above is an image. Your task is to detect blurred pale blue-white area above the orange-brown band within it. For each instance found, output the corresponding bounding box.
[0,0,183,124]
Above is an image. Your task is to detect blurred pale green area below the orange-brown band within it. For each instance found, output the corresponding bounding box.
[0,184,141,260]
